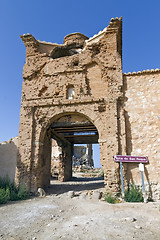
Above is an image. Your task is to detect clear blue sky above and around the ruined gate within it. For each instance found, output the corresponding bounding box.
[0,0,160,142]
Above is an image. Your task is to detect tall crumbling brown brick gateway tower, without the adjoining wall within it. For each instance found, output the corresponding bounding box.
[16,18,125,193]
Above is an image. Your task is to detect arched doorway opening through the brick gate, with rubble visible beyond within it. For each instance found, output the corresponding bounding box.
[40,113,104,193]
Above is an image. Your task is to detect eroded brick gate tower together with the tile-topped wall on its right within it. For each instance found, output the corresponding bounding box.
[16,18,160,199]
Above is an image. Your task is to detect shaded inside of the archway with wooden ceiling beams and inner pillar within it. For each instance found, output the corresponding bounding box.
[37,112,99,190]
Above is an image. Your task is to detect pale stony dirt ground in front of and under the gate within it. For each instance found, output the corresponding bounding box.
[0,173,160,240]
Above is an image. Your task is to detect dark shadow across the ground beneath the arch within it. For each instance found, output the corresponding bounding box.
[46,177,104,194]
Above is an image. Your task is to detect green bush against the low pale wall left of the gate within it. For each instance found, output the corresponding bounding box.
[0,177,29,204]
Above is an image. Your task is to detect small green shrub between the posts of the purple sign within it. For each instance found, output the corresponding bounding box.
[124,183,144,202]
